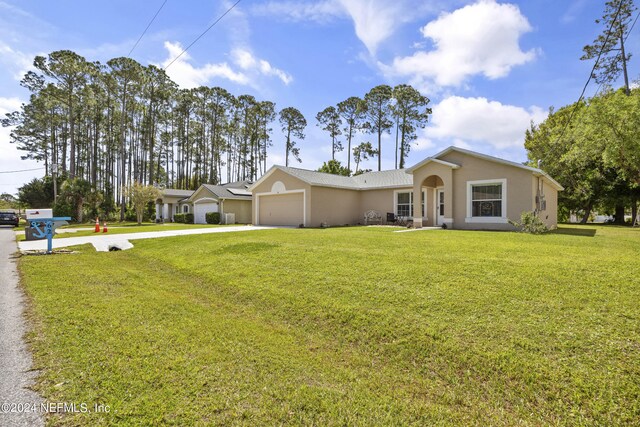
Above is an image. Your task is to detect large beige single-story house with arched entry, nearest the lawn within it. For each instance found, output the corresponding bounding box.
[249,147,563,230]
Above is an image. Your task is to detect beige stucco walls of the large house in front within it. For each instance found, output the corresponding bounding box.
[251,156,557,230]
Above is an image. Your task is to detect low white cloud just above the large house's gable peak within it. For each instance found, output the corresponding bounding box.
[415,96,547,150]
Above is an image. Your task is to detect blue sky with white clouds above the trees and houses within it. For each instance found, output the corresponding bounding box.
[0,0,640,193]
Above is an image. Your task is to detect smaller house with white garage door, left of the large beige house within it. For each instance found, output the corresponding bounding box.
[156,181,251,224]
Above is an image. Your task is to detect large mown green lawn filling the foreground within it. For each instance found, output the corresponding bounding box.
[20,226,640,426]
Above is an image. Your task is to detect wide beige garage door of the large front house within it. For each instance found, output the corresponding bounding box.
[258,193,304,226]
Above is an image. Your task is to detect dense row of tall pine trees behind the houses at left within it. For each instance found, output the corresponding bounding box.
[2,50,276,214]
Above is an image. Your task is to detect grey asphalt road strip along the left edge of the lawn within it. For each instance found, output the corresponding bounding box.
[0,226,44,427]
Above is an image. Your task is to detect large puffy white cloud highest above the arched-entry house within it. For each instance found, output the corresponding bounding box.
[381,0,536,88]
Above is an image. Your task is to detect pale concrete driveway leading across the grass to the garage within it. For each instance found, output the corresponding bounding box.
[18,225,279,252]
